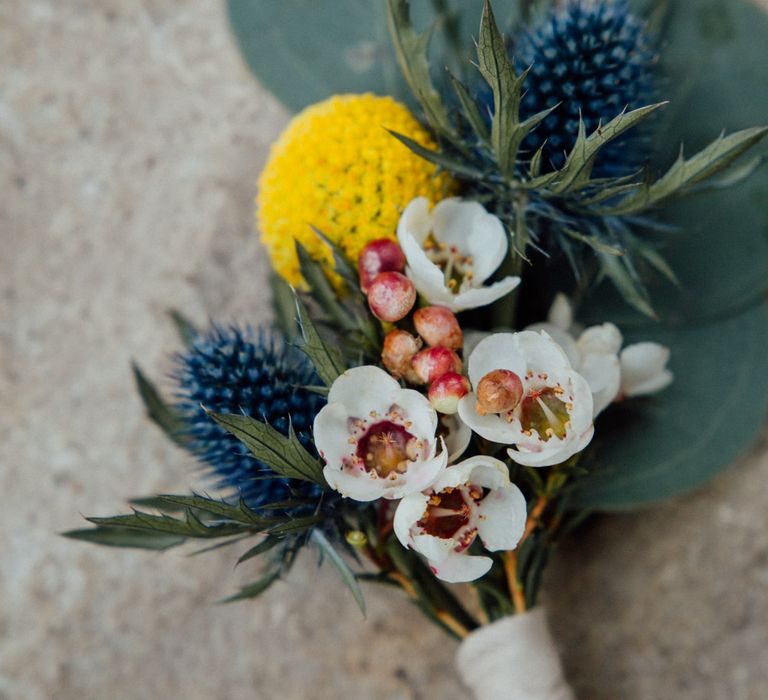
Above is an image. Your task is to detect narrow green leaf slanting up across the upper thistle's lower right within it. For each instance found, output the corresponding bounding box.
[551,102,667,194]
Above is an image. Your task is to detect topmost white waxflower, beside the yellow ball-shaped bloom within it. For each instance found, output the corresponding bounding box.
[397,197,520,311]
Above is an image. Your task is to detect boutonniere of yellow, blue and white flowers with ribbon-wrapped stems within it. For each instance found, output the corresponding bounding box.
[67,0,768,699]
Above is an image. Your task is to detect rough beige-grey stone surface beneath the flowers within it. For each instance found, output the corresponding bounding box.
[0,0,768,700]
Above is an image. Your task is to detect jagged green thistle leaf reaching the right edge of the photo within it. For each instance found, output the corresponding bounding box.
[602,127,768,215]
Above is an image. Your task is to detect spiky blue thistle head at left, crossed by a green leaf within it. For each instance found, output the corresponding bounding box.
[173,326,325,506]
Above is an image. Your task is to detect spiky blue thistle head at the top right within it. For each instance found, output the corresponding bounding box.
[515,0,656,176]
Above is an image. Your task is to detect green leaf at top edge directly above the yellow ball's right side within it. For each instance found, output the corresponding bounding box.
[386,0,456,141]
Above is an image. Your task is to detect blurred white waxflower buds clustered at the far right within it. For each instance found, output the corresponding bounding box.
[528,294,673,416]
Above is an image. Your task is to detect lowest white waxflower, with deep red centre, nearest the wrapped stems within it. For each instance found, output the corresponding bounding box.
[394,456,527,583]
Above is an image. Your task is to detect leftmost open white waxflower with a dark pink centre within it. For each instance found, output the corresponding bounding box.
[314,366,448,501]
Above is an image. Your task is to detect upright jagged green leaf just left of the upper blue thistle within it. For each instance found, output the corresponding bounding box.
[477,0,528,177]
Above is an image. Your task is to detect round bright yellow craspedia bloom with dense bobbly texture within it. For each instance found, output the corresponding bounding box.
[256,94,455,284]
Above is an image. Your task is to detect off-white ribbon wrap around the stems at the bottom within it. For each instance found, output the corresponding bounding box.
[456,608,574,700]
